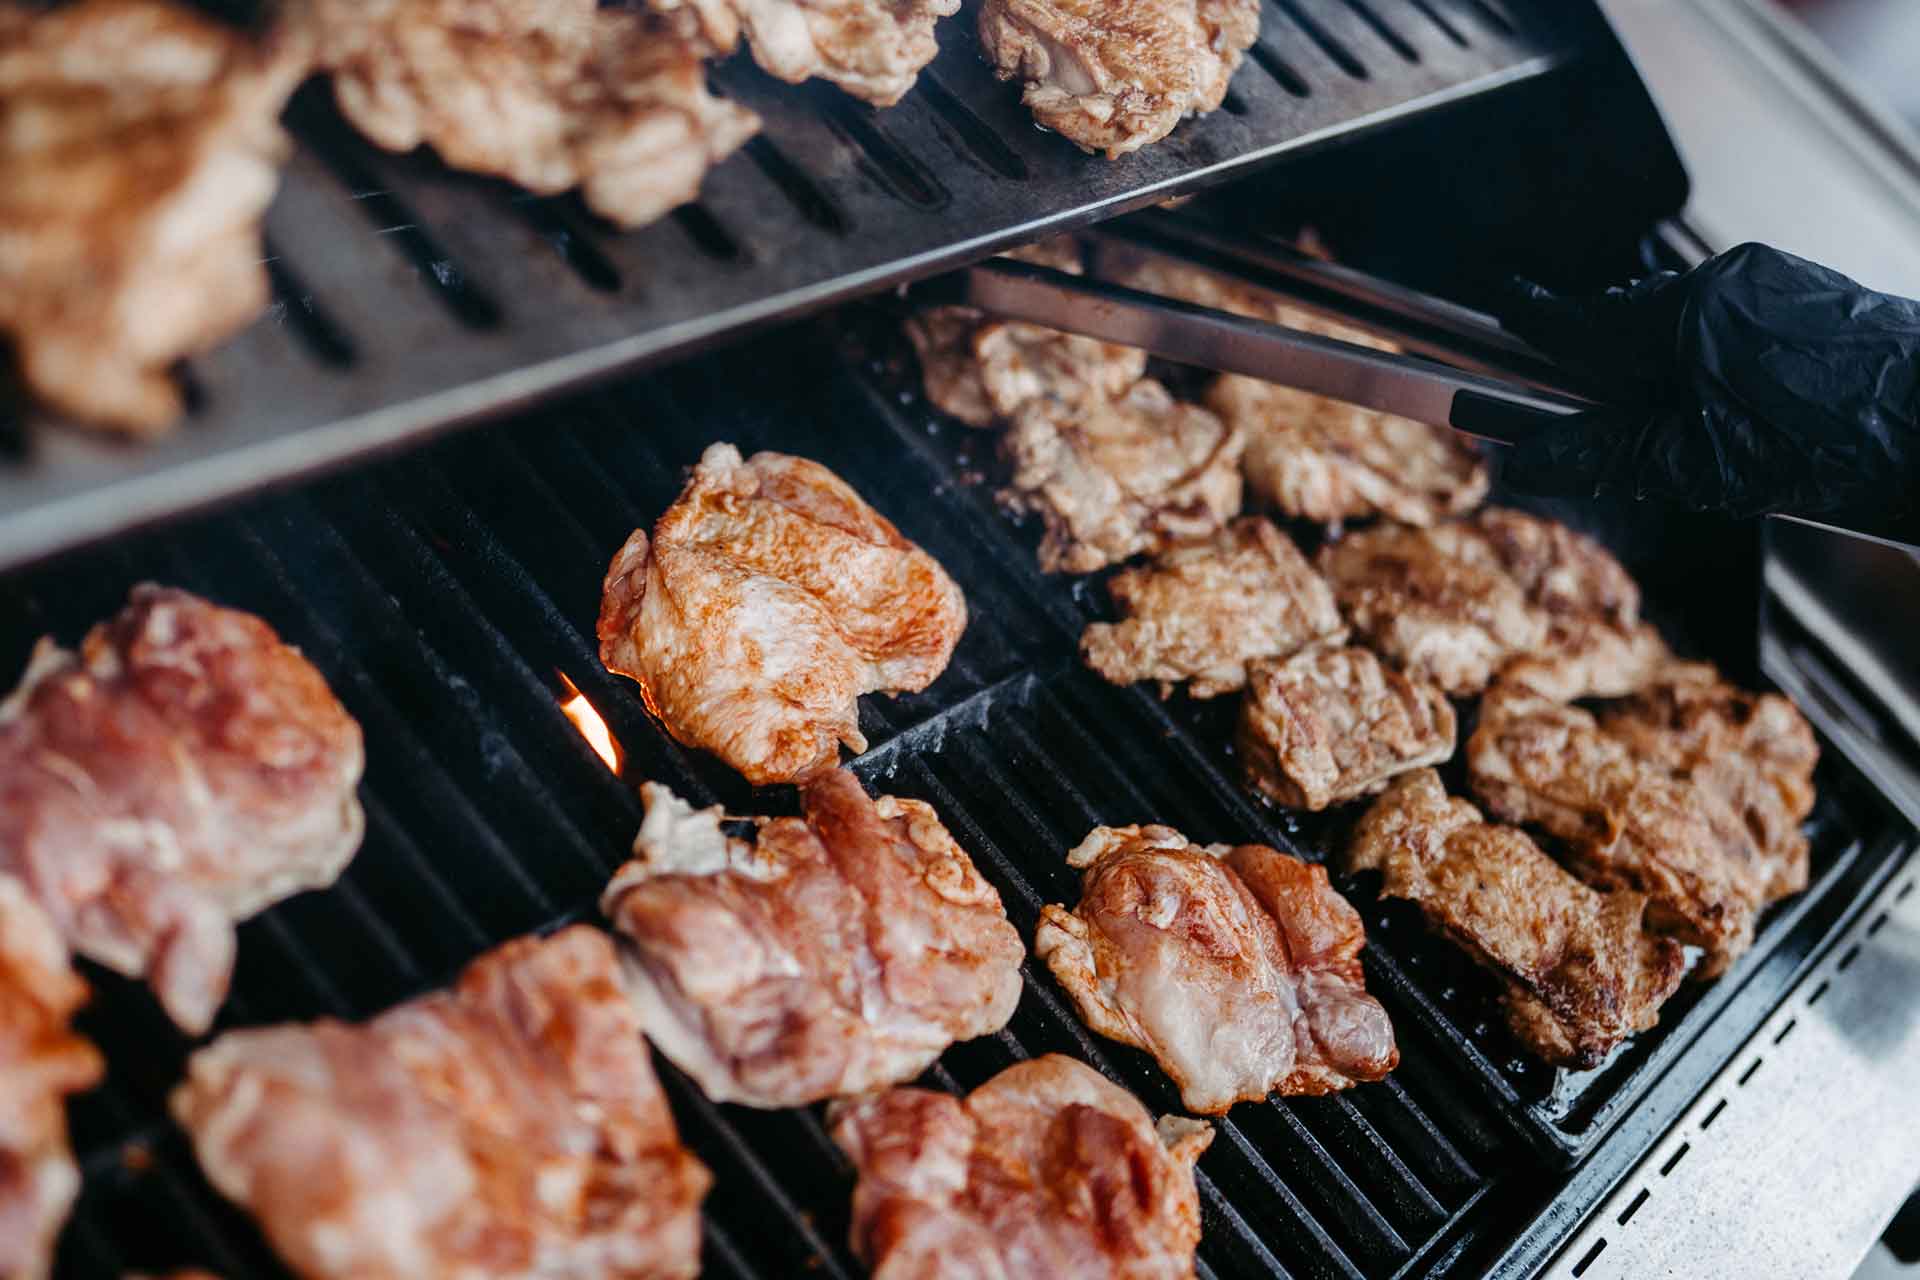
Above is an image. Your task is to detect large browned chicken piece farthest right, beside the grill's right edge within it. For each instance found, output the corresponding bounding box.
[1467,660,1816,977]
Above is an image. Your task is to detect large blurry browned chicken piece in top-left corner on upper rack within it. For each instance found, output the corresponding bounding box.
[0,0,305,436]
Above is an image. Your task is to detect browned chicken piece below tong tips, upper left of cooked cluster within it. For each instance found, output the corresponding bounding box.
[1000,378,1242,574]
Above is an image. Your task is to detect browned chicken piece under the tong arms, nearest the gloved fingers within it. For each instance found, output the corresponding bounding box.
[1206,374,1488,526]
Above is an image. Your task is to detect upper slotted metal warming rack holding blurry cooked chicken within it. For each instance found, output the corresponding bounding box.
[0,0,1576,566]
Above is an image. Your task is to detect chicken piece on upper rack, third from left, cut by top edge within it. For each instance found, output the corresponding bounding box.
[691,0,960,107]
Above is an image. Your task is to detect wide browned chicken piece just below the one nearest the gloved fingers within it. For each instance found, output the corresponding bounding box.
[1319,509,1665,695]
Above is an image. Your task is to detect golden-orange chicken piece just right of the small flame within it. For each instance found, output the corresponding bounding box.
[599,445,966,783]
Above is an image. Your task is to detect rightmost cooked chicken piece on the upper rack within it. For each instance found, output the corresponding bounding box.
[979,0,1260,159]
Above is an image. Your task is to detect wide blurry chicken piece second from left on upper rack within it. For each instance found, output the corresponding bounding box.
[313,0,760,226]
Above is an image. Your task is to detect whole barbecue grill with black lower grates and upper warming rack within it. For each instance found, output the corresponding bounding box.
[0,0,1912,1280]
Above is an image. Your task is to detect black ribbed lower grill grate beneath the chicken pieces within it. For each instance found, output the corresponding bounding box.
[0,312,1891,1280]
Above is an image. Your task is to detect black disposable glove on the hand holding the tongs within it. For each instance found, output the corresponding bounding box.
[1501,244,1920,532]
